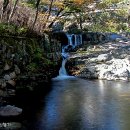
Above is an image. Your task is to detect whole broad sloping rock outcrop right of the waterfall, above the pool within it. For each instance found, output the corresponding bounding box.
[67,42,130,81]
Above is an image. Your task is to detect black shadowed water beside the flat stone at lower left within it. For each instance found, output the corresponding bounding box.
[0,82,52,130]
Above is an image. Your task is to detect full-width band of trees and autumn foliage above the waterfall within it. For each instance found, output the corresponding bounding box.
[0,0,130,34]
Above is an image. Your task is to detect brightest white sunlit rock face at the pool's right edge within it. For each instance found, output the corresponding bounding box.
[96,59,130,80]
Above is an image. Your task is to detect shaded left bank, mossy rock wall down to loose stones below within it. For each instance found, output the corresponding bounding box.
[0,34,61,130]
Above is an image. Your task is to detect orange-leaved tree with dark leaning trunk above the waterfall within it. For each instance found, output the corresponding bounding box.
[42,0,93,29]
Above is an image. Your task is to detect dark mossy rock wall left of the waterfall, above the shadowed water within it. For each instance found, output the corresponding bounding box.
[0,34,61,97]
